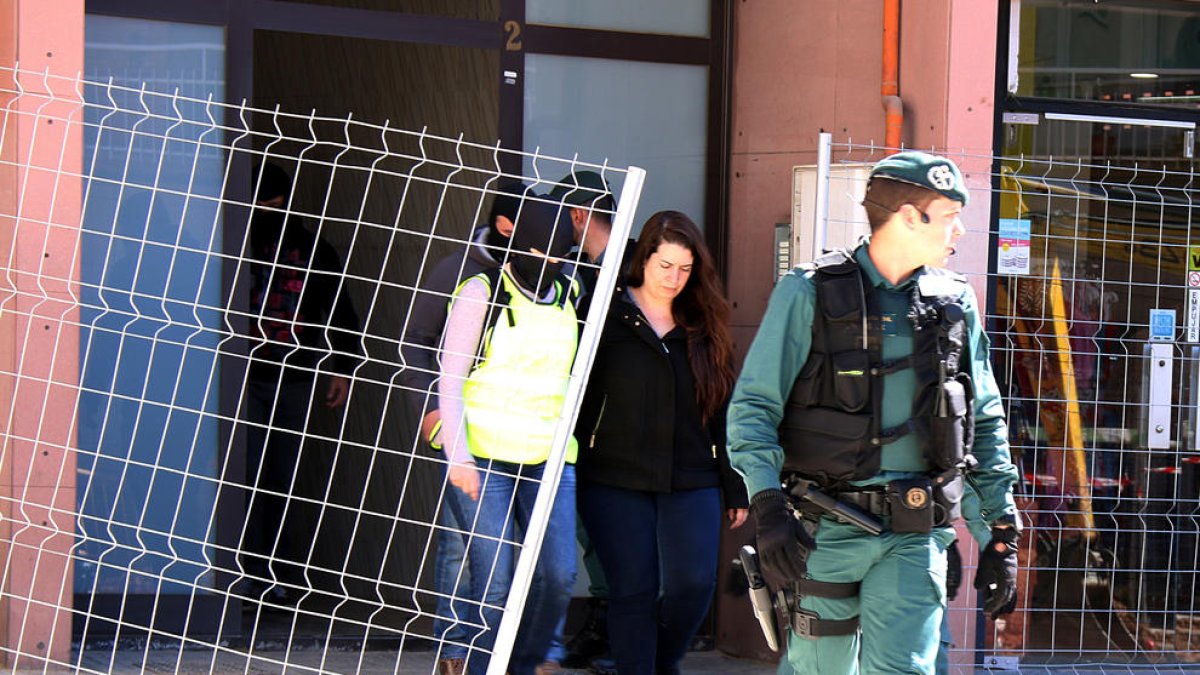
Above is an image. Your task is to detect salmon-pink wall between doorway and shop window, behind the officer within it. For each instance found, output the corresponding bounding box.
[718,0,998,674]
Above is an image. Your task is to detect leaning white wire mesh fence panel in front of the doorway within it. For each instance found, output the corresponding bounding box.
[0,70,643,673]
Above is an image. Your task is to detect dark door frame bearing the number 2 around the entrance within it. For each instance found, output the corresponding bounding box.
[82,0,733,634]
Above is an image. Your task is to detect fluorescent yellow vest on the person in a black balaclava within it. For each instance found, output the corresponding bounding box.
[462,270,580,464]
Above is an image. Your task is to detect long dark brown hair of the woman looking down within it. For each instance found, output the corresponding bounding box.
[625,211,734,423]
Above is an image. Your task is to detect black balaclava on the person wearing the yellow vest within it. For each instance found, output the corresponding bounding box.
[509,199,572,297]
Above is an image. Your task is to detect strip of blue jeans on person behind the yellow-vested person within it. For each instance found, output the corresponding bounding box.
[433,494,470,658]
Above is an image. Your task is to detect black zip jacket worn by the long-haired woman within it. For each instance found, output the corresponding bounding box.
[575,283,748,508]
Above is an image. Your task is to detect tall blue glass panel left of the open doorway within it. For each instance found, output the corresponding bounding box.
[74,14,226,639]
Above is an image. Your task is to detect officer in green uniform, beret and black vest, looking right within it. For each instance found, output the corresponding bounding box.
[728,151,1019,675]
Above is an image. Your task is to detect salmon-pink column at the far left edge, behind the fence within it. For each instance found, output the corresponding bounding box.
[0,0,84,669]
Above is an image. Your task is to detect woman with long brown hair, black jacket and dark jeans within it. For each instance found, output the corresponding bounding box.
[576,211,746,675]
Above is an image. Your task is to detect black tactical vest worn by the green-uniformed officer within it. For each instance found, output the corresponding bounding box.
[779,251,974,485]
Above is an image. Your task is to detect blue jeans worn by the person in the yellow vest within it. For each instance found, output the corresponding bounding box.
[446,460,575,675]
